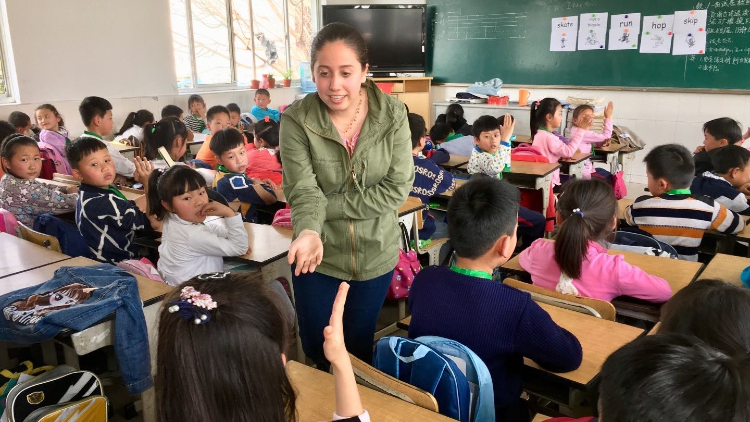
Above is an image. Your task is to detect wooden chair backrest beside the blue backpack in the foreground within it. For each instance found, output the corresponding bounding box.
[349,354,438,412]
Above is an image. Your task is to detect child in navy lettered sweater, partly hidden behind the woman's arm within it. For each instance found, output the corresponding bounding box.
[408,113,456,244]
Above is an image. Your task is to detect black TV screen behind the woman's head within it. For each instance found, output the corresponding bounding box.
[323,4,425,73]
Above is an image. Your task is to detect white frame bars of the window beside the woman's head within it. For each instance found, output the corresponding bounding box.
[178,0,321,94]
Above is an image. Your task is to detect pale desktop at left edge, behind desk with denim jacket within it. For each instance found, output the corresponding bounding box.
[0,232,70,280]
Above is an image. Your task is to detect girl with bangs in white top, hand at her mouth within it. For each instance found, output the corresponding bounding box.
[146,166,248,286]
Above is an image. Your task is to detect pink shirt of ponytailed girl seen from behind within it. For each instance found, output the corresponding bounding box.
[518,239,672,303]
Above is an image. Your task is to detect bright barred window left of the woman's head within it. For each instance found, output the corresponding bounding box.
[169,0,317,89]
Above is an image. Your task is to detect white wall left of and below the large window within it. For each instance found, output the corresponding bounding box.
[0,0,299,136]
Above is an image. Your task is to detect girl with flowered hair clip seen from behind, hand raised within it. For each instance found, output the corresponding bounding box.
[154,273,370,422]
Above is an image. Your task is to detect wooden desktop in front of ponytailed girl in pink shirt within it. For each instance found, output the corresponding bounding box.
[502,240,703,294]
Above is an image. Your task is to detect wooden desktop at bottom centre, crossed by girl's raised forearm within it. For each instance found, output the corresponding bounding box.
[286,361,455,422]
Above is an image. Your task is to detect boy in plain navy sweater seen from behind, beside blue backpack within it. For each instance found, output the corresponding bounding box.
[409,178,582,422]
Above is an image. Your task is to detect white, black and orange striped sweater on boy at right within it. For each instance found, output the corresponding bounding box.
[625,193,745,261]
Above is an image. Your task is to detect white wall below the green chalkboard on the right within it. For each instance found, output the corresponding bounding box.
[432,86,750,183]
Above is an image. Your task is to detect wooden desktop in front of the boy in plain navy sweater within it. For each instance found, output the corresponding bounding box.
[398,303,644,389]
